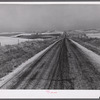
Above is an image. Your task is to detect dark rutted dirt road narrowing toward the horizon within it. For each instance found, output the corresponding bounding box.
[0,38,100,89]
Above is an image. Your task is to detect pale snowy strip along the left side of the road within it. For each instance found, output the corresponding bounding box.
[0,39,62,88]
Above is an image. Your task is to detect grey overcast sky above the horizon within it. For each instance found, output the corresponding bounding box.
[0,4,100,32]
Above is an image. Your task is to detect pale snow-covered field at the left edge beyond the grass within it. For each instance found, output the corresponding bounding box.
[0,36,32,46]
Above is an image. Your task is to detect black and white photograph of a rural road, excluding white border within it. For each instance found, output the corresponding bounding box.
[0,4,100,92]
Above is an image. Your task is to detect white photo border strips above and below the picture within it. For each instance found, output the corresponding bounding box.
[0,1,100,99]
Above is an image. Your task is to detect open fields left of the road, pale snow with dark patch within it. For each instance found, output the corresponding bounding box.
[0,33,60,46]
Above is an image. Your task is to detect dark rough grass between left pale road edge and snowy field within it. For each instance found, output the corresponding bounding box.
[0,39,55,78]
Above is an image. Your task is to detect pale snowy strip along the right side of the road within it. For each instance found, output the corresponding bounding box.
[69,39,100,72]
